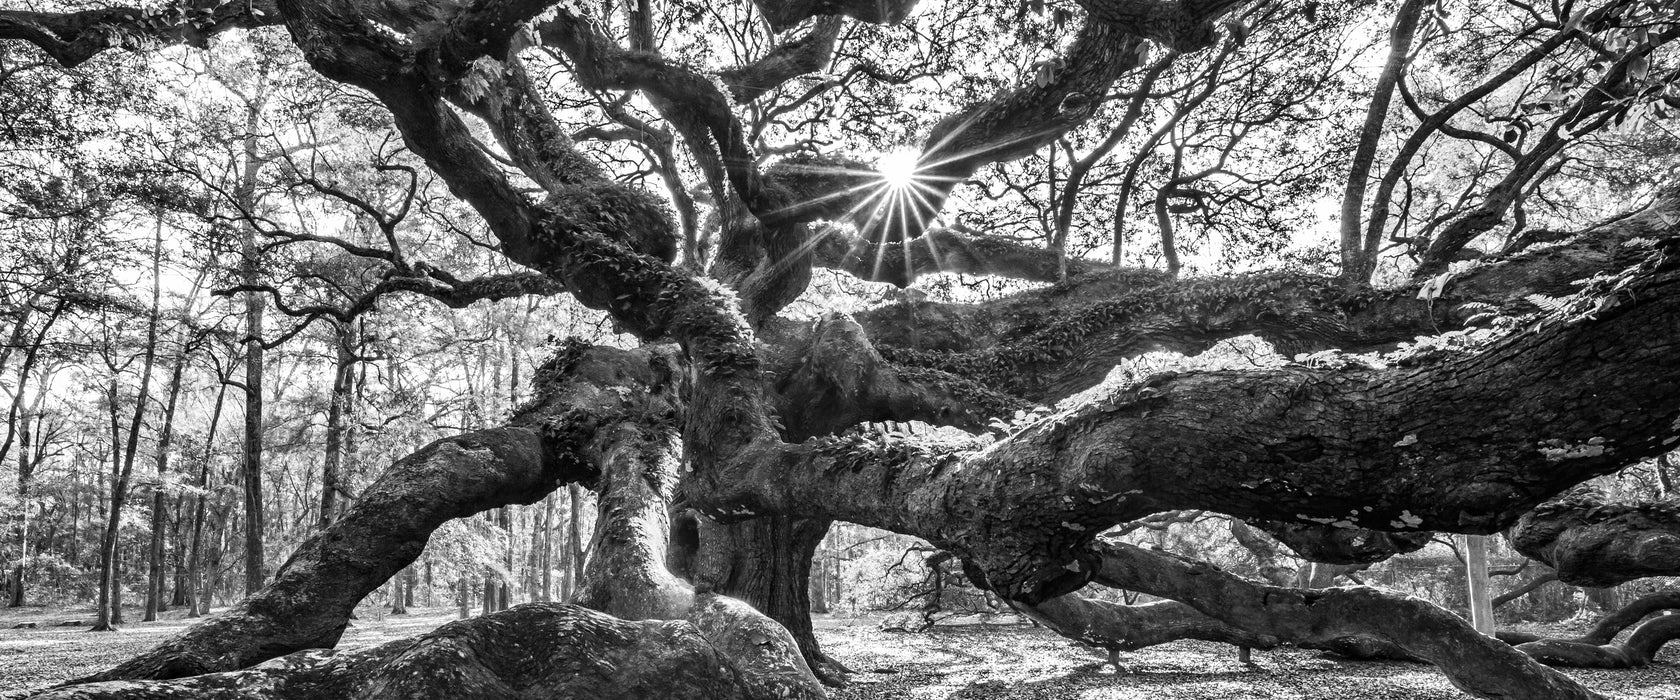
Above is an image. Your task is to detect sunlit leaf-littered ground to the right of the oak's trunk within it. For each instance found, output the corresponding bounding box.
[816,619,1680,700]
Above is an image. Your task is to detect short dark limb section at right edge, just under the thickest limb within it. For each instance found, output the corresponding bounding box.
[1510,490,1680,588]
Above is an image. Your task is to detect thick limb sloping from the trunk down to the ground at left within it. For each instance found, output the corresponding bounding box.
[68,344,672,680]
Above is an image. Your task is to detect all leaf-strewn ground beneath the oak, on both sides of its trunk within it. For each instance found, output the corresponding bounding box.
[0,608,1680,700]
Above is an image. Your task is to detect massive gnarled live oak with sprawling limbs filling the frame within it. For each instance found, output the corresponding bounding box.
[0,0,1680,698]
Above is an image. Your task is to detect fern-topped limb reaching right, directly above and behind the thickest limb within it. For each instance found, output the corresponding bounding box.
[858,188,1680,401]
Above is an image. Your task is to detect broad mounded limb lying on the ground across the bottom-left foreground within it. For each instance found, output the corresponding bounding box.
[21,603,783,700]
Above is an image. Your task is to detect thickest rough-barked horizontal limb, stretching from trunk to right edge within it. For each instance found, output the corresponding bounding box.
[689,243,1680,599]
